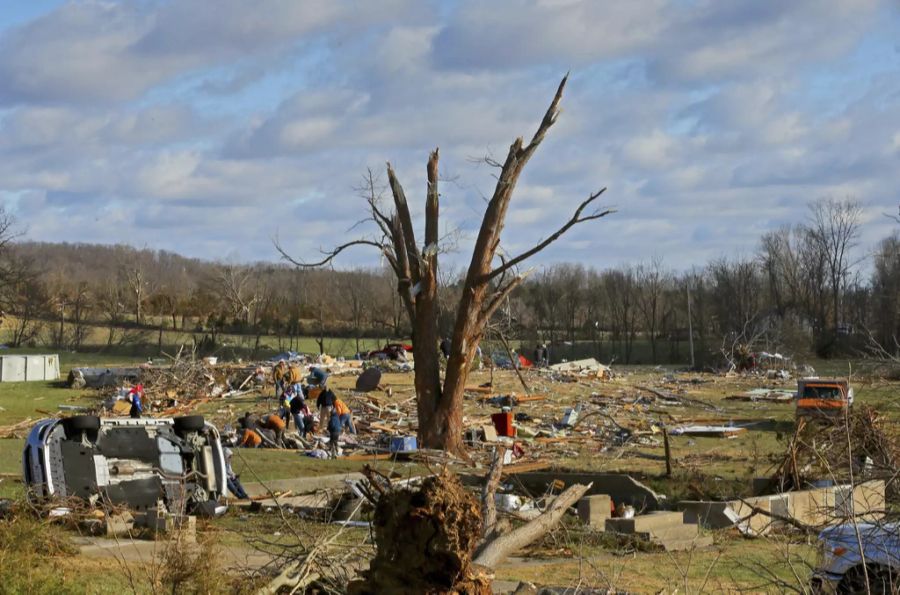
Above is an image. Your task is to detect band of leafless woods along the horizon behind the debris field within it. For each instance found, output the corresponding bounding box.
[0,199,900,365]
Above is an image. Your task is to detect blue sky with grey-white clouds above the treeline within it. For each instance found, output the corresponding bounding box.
[0,0,900,269]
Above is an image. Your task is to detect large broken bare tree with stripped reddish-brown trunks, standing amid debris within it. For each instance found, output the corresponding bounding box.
[276,76,612,453]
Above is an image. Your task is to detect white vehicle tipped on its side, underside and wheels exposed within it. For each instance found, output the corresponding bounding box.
[22,415,227,515]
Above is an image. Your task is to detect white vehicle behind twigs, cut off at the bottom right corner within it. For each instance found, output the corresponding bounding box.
[810,523,900,594]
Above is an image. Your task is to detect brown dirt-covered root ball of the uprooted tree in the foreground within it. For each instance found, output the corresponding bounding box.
[349,470,492,595]
